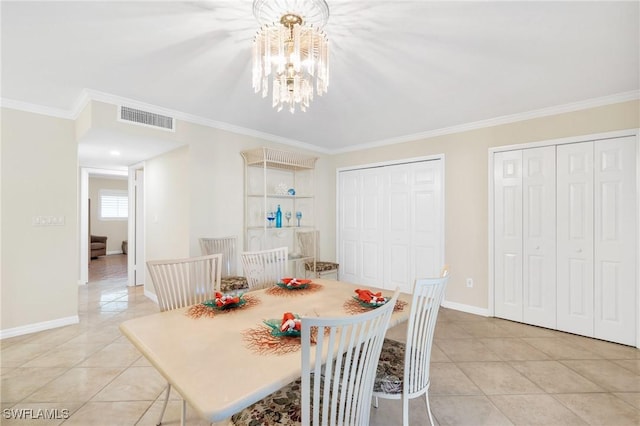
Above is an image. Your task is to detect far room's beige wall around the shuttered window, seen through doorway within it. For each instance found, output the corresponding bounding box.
[89,177,128,253]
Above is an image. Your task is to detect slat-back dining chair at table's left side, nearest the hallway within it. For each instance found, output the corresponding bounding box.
[147,253,222,425]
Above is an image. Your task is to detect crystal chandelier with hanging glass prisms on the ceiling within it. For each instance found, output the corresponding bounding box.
[253,0,329,113]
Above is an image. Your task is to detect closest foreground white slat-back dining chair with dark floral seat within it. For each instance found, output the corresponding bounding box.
[231,290,399,425]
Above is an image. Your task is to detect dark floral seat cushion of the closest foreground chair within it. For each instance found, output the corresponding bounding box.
[231,379,302,426]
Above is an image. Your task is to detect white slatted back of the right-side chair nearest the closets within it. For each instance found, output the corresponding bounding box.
[404,274,449,395]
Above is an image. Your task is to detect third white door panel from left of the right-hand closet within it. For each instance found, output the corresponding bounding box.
[556,142,594,336]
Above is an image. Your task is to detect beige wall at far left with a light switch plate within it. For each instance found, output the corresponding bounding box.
[0,108,78,336]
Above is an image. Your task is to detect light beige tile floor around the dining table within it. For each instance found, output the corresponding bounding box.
[0,255,640,426]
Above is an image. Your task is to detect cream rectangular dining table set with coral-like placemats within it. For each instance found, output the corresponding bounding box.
[120,279,411,423]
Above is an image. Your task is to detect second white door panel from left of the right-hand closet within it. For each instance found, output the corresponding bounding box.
[522,146,556,328]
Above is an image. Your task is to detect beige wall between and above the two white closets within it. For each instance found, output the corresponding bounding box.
[333,101,640,308]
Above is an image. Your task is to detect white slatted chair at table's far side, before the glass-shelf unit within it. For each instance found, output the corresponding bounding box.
[240,247,289,291]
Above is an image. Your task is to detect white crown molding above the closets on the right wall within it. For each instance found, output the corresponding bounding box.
[331,90,640,154]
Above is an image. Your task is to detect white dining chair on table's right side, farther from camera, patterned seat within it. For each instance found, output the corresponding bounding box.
[373,268,449,426]
